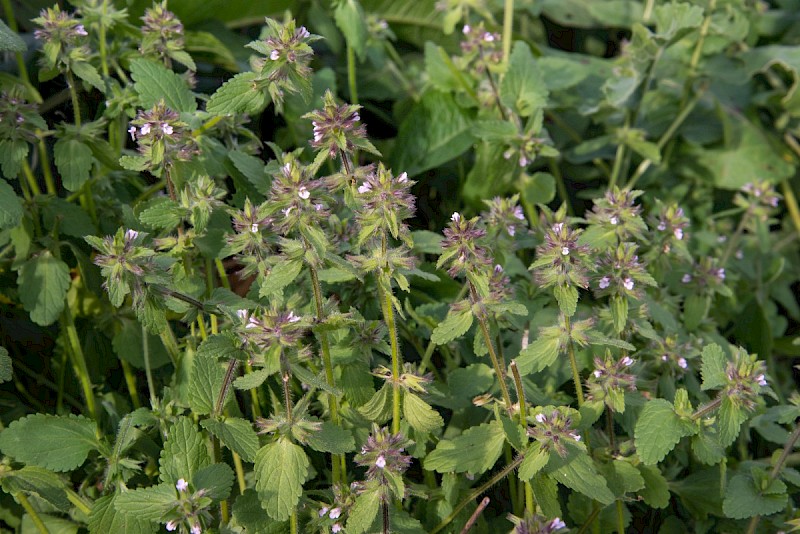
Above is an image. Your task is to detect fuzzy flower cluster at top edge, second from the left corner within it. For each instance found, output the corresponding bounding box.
[139,0,195,70]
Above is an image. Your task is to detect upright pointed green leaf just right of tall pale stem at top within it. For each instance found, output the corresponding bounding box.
[500,41,548,117]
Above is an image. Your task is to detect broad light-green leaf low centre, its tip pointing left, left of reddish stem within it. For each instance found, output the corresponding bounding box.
[423,421,506,475]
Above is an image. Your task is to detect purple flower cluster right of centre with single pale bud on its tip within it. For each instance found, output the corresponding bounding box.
[436,212,492,277]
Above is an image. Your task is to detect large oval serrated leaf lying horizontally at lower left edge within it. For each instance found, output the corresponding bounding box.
[0,414,98,471]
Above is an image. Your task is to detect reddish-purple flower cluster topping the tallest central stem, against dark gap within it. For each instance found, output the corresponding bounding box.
[303,90,380,159]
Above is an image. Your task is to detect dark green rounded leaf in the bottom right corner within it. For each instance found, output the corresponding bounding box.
[722,474,789,519]
